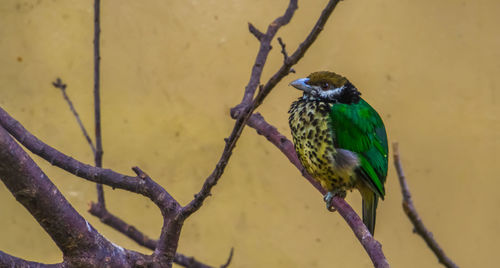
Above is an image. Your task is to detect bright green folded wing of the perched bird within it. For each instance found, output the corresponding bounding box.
[330,99,388,199]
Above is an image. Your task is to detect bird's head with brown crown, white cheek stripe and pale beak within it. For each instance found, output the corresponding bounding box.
[290,71,361,104]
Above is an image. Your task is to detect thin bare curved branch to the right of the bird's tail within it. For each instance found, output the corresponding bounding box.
[392,142,458,268]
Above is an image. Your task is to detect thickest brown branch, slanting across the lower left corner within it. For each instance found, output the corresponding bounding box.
[0,127,149,267]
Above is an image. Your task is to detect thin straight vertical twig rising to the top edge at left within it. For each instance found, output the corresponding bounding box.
[94,0,106,207]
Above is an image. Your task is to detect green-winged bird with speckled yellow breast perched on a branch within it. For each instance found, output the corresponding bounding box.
[289,71,388,234]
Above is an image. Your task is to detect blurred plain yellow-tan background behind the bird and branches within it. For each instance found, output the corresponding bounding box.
[0,0,500,268]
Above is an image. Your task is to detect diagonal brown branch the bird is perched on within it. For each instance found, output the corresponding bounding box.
[247,113,389,267]
